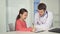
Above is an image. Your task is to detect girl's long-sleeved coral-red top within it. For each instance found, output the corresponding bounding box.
[16,19,32,32]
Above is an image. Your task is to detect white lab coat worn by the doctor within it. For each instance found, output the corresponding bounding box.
[34,11,53,31]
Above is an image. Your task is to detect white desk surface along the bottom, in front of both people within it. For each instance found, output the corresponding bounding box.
[0,31,60,34]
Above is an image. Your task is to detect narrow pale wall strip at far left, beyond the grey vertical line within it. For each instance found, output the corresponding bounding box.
[0,0,6,32]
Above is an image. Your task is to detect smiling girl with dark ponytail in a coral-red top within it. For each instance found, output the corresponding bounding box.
[15,8,32,32]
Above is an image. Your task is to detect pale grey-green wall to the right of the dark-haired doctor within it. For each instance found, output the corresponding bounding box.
[40,0,60,27]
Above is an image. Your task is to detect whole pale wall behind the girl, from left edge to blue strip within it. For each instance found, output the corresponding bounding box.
[0,0,33,32]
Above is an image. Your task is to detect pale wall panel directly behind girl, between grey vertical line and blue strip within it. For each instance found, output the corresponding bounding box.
[7,0,33,30]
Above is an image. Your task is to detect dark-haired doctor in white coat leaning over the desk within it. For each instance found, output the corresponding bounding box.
[34,3,53,31]
